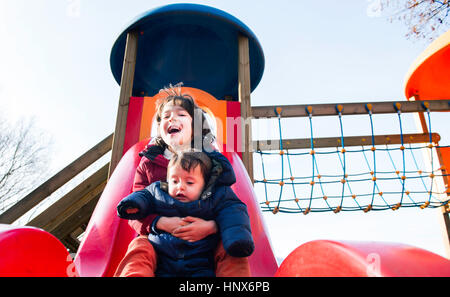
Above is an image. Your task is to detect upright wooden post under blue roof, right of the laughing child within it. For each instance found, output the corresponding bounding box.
[238,35,253,182]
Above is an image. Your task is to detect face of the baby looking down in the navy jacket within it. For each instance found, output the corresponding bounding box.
[167,165,205,202]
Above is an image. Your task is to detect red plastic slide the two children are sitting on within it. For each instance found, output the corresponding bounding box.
[75,139,278,276]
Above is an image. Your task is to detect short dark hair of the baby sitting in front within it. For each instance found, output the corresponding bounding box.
[168,151,212,185]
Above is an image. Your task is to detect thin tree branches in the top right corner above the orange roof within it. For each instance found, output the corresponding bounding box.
[371,0,450,40]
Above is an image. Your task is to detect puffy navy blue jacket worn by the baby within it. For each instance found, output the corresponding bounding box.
[117,152,254,276]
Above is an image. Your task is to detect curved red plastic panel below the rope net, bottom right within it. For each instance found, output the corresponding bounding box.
[275,240,450,277]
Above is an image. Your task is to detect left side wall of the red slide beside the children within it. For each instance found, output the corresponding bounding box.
[75,139,148,277]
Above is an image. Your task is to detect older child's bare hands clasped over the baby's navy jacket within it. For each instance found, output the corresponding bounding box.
[172,217,217,242]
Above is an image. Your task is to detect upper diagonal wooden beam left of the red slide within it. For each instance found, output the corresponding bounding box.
[0,134,113,224]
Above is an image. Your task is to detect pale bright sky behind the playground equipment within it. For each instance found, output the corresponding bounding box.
[0,0,448,259]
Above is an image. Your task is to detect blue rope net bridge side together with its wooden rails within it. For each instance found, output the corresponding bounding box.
[255,101,448,214]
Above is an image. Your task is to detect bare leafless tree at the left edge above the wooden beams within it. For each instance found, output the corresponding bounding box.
[0,115,50,213]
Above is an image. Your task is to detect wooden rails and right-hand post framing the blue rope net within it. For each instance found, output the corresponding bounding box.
[251,97,450,259]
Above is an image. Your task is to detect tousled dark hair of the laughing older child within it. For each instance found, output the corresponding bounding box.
[155,83,215,150]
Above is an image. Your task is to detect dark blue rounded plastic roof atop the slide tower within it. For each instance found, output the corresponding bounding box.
[110,4,264,100]
